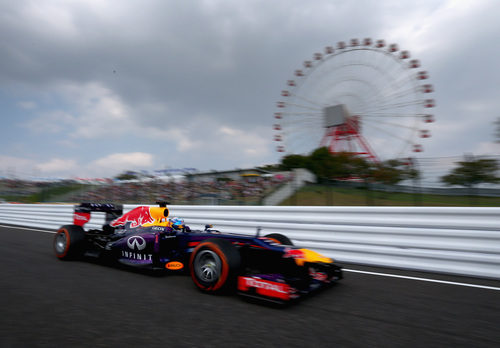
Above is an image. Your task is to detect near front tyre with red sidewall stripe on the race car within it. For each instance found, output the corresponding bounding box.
[189,238,241,293]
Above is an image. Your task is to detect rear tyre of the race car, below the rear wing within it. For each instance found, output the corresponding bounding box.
[53,225,85,260]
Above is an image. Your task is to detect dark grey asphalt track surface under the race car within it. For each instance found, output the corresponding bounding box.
[0,227,500,348]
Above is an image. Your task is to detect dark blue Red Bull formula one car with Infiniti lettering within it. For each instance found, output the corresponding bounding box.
[53,203,342,303]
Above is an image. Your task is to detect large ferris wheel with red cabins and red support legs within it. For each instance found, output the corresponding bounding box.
[273,38,435,162]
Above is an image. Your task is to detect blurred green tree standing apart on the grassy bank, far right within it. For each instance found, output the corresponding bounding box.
[441,159,500,188]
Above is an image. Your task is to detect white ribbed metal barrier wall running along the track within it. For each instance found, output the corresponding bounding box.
[0,204,500,279]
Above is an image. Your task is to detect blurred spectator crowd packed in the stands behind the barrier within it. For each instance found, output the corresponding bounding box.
[0,174,290,205]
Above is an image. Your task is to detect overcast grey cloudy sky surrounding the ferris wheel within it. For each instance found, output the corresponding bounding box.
[0,0,500,177]
